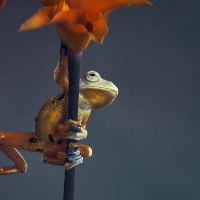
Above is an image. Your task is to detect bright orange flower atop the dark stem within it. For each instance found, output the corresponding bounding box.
[19,0,152,52]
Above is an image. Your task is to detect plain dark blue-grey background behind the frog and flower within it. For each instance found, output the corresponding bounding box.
[0,0,200,200]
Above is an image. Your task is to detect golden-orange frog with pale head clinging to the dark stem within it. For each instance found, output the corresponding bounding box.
[0,52,118,175]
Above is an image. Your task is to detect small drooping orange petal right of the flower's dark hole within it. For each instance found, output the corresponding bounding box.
[89,17,108,44]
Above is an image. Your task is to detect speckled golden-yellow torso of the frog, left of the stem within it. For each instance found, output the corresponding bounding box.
[35,94,67,143]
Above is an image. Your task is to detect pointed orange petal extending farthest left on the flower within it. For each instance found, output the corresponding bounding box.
[19,6,53,31]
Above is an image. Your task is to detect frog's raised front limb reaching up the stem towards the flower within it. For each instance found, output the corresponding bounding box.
[54,45,69,92]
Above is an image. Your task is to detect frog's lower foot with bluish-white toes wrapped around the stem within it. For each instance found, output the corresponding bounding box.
[58,142,83,170]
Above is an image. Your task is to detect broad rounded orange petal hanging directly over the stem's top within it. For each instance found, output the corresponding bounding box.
[56,23,91,52]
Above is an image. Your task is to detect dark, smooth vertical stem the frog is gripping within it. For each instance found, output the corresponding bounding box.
[63,50,82,200]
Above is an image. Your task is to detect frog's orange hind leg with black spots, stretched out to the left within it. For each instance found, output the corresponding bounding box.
[0,132,66,174]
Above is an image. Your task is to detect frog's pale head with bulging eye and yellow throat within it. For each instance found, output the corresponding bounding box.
[80,71,118,110]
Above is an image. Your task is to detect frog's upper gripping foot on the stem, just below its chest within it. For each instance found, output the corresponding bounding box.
[58,119,87,140]
